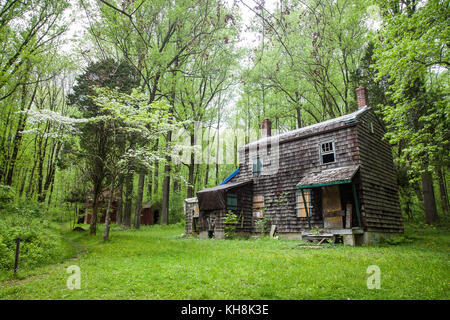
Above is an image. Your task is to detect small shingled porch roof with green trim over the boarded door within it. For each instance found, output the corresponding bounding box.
[297,165,359,189]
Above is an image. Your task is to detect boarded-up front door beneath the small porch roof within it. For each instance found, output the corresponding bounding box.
[322,185,344,229]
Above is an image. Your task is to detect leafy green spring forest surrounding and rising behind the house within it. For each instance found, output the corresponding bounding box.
[0,0,450,300]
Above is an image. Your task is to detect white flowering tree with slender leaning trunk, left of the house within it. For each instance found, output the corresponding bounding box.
[93,88,187,241]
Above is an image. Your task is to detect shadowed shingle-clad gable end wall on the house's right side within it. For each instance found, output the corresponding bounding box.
[357,110,403,232]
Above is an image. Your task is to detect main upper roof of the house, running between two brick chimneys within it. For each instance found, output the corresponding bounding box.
[241,106,370,148]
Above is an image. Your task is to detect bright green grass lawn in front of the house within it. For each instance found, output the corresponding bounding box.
[0,225,450,300]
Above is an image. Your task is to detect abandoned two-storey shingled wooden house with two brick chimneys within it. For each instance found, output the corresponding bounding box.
[185,87,403,245]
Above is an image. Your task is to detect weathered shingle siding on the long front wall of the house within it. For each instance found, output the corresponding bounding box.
[235,122,359,232]
